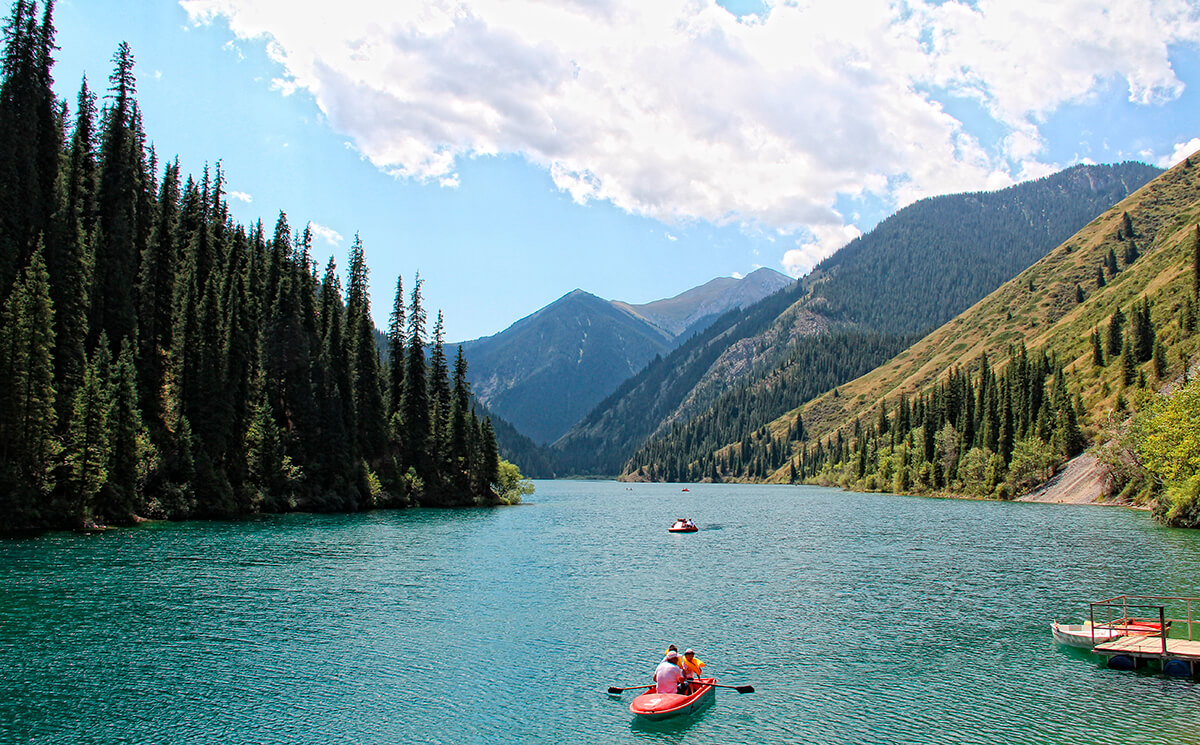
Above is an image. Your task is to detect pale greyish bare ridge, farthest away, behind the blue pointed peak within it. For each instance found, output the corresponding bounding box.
[613,266,796,337]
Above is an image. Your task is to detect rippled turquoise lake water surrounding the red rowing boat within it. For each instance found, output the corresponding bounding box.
[0,481,1200,745]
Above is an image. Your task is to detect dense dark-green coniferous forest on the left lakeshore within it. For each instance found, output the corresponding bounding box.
[0,0,526,529]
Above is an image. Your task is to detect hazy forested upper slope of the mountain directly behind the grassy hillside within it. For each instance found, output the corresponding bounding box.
[812,163,1162,334]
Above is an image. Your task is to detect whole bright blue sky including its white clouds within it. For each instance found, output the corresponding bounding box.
[54,0,1200,341]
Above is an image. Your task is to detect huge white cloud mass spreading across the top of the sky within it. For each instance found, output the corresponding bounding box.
[181,0,1200,267]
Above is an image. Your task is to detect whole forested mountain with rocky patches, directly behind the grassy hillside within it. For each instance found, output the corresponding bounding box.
[554,163,1160,477]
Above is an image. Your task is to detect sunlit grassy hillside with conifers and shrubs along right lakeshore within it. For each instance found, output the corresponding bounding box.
[697,151,1200,527]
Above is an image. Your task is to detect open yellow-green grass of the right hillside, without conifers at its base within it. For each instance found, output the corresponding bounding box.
[748,156,1200,518]
